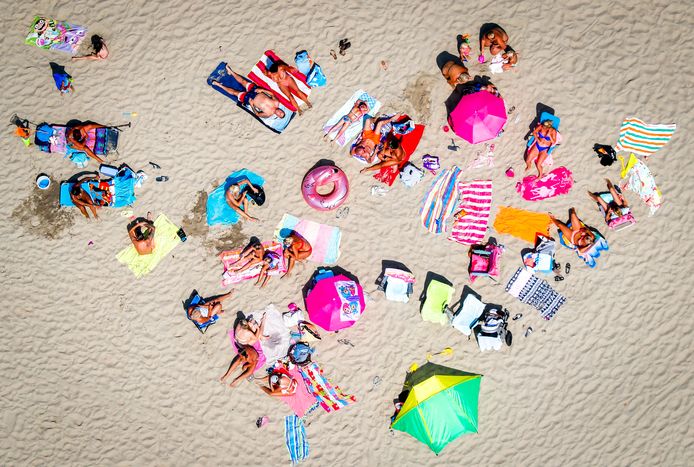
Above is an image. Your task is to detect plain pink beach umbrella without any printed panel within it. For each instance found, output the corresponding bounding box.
[448,91,506,144]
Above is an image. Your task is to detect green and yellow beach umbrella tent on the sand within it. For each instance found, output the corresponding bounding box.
[392,363,482,454]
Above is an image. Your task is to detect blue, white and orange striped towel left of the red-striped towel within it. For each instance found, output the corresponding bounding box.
[419,165,462,234]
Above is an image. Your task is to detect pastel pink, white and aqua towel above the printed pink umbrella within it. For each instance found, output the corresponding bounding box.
[275,214,342,264]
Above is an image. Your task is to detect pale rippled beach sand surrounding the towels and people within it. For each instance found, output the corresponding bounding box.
[0,0,694,466]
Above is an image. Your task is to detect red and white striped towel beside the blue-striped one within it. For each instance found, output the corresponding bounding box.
[448,180,492,245]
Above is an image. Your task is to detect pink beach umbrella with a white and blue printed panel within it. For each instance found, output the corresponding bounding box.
[306,274,366,331]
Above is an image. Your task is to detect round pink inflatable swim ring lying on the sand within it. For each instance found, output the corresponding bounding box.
[301,165,349,211]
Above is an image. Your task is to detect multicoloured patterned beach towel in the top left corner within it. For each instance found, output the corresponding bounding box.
[24,16,87,54]
